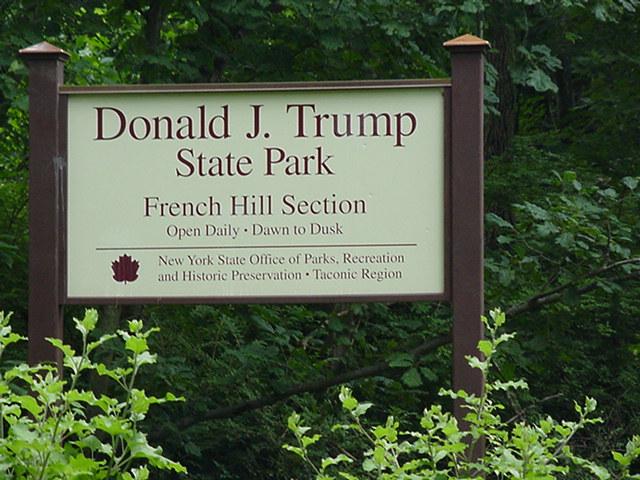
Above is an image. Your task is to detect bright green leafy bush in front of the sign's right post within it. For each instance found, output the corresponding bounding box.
[284,311,640,480]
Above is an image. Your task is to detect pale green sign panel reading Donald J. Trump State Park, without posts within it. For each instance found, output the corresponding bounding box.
[63,82,447,302]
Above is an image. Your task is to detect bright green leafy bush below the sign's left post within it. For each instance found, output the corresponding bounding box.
[0,310,186,480]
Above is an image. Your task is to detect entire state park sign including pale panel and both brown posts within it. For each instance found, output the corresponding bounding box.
[20,35,488,420]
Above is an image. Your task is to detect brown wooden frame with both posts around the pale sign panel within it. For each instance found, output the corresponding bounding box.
[20,35,489,419]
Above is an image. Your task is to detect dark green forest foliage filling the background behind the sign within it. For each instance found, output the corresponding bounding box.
[0,0,640,480]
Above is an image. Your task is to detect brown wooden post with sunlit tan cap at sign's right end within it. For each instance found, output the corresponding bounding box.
[444,35,489,420]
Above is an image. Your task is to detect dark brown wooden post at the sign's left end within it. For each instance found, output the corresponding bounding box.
[20,42,69,368]
